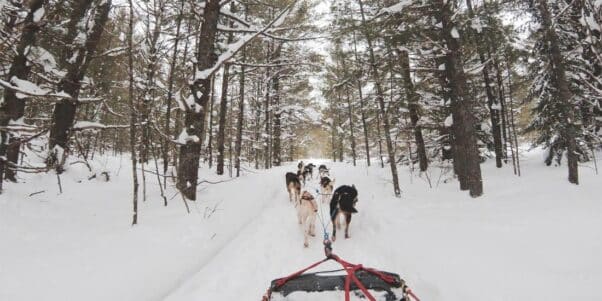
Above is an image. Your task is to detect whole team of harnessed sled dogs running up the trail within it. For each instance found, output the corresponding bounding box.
[286,161,358,247]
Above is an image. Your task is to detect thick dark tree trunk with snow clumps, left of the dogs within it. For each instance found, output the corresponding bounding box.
[177,0,220,200]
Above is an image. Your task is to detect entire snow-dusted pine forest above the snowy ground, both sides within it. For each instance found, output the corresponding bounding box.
[0,0,602,219]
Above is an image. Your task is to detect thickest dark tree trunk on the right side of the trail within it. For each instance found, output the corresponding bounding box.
[437,0,483,197]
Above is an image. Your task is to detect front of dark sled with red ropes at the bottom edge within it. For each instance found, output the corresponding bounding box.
[262,234,420,301]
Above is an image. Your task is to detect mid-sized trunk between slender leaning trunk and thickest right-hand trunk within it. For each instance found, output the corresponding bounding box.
[399,50,428,171]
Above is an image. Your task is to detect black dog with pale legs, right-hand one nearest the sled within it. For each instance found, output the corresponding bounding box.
[330,185,358,241]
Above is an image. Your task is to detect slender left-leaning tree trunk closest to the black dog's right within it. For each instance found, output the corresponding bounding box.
[358,0,401,197]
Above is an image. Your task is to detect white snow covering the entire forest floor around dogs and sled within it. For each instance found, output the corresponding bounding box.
[0,151,602,301]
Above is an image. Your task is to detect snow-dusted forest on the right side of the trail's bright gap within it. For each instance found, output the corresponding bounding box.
[324,0,602,197]
